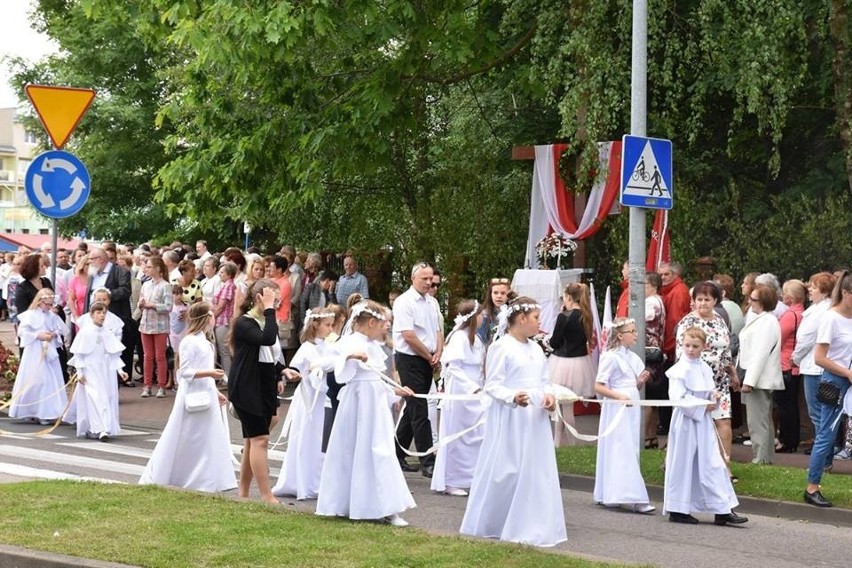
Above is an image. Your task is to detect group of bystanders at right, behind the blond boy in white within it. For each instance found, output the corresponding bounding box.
[617,263,852,507]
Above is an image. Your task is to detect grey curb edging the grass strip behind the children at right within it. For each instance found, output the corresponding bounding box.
[559,473,852,527]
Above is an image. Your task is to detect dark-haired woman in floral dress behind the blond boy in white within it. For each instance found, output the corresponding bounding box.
[677,281,740,481]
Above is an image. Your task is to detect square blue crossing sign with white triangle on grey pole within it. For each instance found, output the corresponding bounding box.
[620,135,674,209]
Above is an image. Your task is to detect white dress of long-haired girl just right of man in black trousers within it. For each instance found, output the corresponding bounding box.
[431,330,485,491]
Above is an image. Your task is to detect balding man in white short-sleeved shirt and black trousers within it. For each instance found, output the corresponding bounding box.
[393,262,444,477]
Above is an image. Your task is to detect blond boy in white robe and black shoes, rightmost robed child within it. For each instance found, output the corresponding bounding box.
[663,327,748,525]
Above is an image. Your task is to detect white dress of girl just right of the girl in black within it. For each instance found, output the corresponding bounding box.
[272,339,335,499]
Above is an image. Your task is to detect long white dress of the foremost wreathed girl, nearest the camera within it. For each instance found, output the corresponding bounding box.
[459,335,567,546]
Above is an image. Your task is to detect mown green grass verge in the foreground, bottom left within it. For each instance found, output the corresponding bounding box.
[0,481,628,568]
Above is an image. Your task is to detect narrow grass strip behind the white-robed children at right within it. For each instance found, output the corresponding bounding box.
[556,446,852,509]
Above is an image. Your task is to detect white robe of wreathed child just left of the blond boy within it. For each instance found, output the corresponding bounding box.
[594,347,648,505]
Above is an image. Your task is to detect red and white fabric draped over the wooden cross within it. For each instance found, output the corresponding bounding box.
[524,141,621,268]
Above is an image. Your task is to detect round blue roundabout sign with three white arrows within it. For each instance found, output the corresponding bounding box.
[24,150,91,219]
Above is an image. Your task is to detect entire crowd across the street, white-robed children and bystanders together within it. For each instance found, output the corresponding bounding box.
[0,241,852,546]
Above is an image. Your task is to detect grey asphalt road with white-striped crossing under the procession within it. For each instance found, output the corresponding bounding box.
[0,408,850,568]
